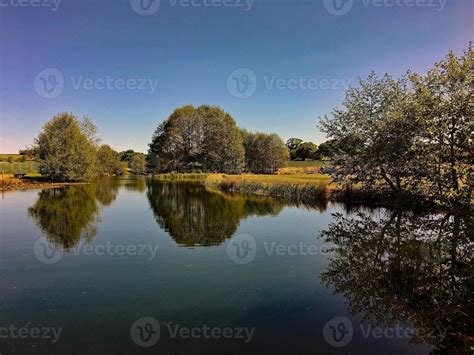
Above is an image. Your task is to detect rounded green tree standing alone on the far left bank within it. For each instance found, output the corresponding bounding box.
[35,113,97,181]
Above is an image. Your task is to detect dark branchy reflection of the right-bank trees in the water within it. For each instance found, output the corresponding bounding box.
[321,212,474,353]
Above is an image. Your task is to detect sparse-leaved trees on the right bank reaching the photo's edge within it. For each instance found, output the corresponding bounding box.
[320,45,474,205]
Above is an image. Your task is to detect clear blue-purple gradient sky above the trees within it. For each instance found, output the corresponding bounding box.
[0,0,474,153]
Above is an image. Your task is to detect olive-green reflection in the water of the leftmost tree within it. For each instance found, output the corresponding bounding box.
[28,179,120,251]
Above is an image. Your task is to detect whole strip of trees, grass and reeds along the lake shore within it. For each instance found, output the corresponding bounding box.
[0,45,474,210]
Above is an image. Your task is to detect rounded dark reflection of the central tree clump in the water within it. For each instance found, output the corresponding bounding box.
[147,181,284,246]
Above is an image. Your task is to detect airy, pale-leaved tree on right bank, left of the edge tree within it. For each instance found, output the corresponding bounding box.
[321,73,420,194]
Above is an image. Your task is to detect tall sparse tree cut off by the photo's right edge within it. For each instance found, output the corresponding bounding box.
[411,45,474,203]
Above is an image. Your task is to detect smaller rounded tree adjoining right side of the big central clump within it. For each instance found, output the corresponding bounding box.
[242,130,288,174]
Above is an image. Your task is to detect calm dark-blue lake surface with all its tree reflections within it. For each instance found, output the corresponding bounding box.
[0,178,473,355]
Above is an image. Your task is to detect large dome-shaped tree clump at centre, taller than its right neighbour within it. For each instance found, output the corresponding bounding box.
[148,105,244,173]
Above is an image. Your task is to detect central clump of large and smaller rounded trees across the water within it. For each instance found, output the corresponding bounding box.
[148,105,288,174]
